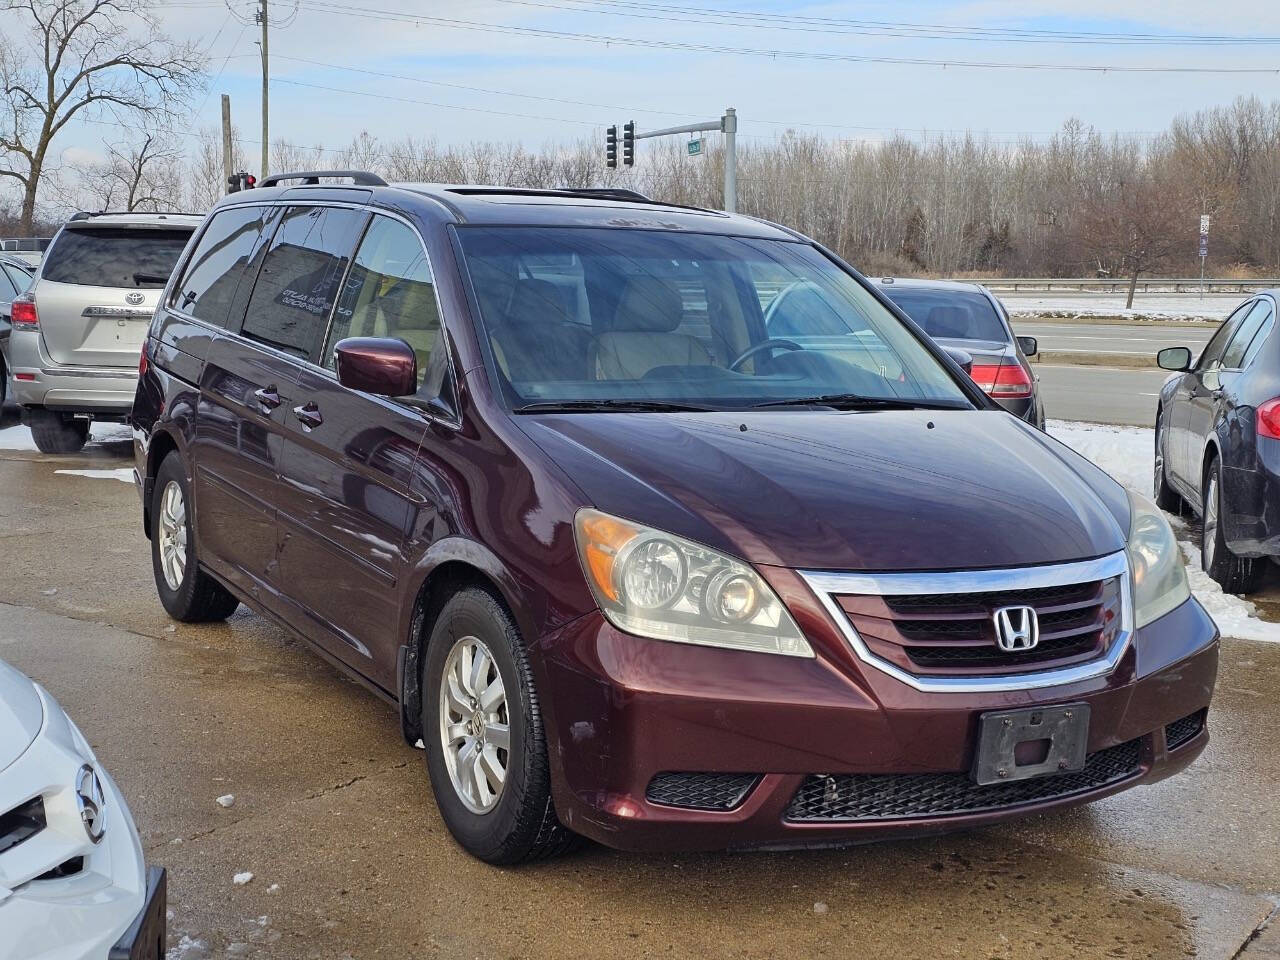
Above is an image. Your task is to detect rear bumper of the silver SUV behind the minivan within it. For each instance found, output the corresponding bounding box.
[9,330,138,417]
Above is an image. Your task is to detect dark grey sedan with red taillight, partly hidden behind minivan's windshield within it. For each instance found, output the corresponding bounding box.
[879,276,1044,430]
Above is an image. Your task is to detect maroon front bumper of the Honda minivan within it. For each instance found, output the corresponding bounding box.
[543,596,1219,850]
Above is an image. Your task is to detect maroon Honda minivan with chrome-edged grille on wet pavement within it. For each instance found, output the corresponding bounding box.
[132,173,1219,863]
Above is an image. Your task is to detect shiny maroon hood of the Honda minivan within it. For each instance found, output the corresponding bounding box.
[517,411,1129,571]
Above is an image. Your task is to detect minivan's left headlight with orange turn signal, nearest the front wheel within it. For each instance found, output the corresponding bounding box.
[573,509,813,657]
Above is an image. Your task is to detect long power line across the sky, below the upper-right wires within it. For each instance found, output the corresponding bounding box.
[290,0,1280,74]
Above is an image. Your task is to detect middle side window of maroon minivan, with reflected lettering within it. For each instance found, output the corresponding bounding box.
[241,206,366,360]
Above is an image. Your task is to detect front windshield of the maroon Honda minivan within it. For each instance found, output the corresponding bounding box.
[457,227,970,412]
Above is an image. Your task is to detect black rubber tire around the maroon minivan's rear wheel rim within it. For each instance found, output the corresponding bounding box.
[151,452,239,623]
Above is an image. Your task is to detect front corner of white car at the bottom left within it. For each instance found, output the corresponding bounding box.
[0,660,166,960]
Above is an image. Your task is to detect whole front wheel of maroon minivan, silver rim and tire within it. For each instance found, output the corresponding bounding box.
[421,588,575,864]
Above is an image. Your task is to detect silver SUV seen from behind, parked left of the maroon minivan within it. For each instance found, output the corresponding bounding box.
[9,214,201,453]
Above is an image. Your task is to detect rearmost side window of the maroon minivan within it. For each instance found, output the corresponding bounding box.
[170,206,269,326]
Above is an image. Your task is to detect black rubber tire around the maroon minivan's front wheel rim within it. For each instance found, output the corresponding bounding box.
[421,586,577,864]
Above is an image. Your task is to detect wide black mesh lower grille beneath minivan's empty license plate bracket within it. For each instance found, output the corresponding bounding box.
[786,739,1142,823]
